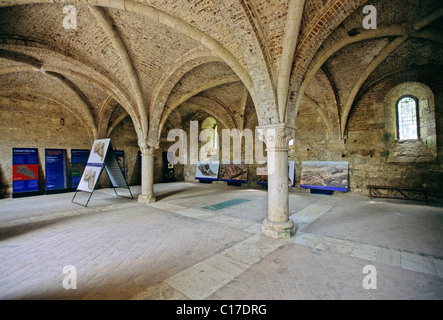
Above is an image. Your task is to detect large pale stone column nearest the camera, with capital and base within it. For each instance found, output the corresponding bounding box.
[258,124,295,238]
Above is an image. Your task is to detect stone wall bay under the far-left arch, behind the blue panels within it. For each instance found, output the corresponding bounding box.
[0,96,92,198]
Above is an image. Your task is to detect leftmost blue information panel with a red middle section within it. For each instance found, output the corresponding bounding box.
[12,148,39,194]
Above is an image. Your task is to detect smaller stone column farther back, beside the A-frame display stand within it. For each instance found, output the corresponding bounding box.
[138,143,159,204]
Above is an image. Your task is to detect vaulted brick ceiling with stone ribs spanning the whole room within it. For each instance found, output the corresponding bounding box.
[0,0,443,144]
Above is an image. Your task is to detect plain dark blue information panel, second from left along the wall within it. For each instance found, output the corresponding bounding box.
[45,149,68,191]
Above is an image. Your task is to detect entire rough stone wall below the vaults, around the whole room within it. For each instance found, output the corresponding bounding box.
[0,78,443,201]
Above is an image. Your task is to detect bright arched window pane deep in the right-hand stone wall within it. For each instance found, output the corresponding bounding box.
[397,96,419,140]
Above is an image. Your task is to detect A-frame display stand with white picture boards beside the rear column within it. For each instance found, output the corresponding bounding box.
[71,139,134,207]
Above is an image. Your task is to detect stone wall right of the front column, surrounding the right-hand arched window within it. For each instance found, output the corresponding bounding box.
[290,83,443,197]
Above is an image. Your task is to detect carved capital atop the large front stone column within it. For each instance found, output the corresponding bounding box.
[256,123,297,151]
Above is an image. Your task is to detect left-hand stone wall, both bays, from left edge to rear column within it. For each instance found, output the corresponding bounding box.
[0,97,146,198]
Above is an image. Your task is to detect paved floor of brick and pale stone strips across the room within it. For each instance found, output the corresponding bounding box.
[0,182,443,300]
